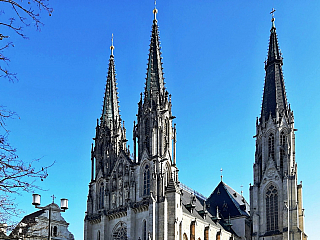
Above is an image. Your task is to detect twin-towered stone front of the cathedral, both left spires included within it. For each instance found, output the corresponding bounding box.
[84,8,182,240]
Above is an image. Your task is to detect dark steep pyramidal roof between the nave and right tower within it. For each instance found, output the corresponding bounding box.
[207,181,250,219]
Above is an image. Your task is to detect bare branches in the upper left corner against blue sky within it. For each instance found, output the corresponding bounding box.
[0,0,53,81]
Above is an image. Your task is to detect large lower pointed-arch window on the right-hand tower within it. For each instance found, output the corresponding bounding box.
[266,184,278,231]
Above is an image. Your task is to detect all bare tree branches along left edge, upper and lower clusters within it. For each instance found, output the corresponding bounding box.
[0,0,53,231]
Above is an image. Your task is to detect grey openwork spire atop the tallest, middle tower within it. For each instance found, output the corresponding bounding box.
[145,2,164,100]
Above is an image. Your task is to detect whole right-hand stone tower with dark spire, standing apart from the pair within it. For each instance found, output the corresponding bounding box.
[250,10,307,240]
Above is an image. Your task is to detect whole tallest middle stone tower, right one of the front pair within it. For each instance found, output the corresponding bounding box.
[133,7,180,240]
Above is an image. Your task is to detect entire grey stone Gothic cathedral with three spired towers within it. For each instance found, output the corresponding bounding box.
[84,5,307,240]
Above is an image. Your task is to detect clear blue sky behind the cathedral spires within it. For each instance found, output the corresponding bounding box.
[0,0,320,239]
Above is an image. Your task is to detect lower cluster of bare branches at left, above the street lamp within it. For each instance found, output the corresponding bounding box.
[0,106,52,230]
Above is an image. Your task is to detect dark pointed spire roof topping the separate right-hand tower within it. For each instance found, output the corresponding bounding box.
[261,9,288,121]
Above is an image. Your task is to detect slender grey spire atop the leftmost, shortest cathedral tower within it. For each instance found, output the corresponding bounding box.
[101,34,121,129]
